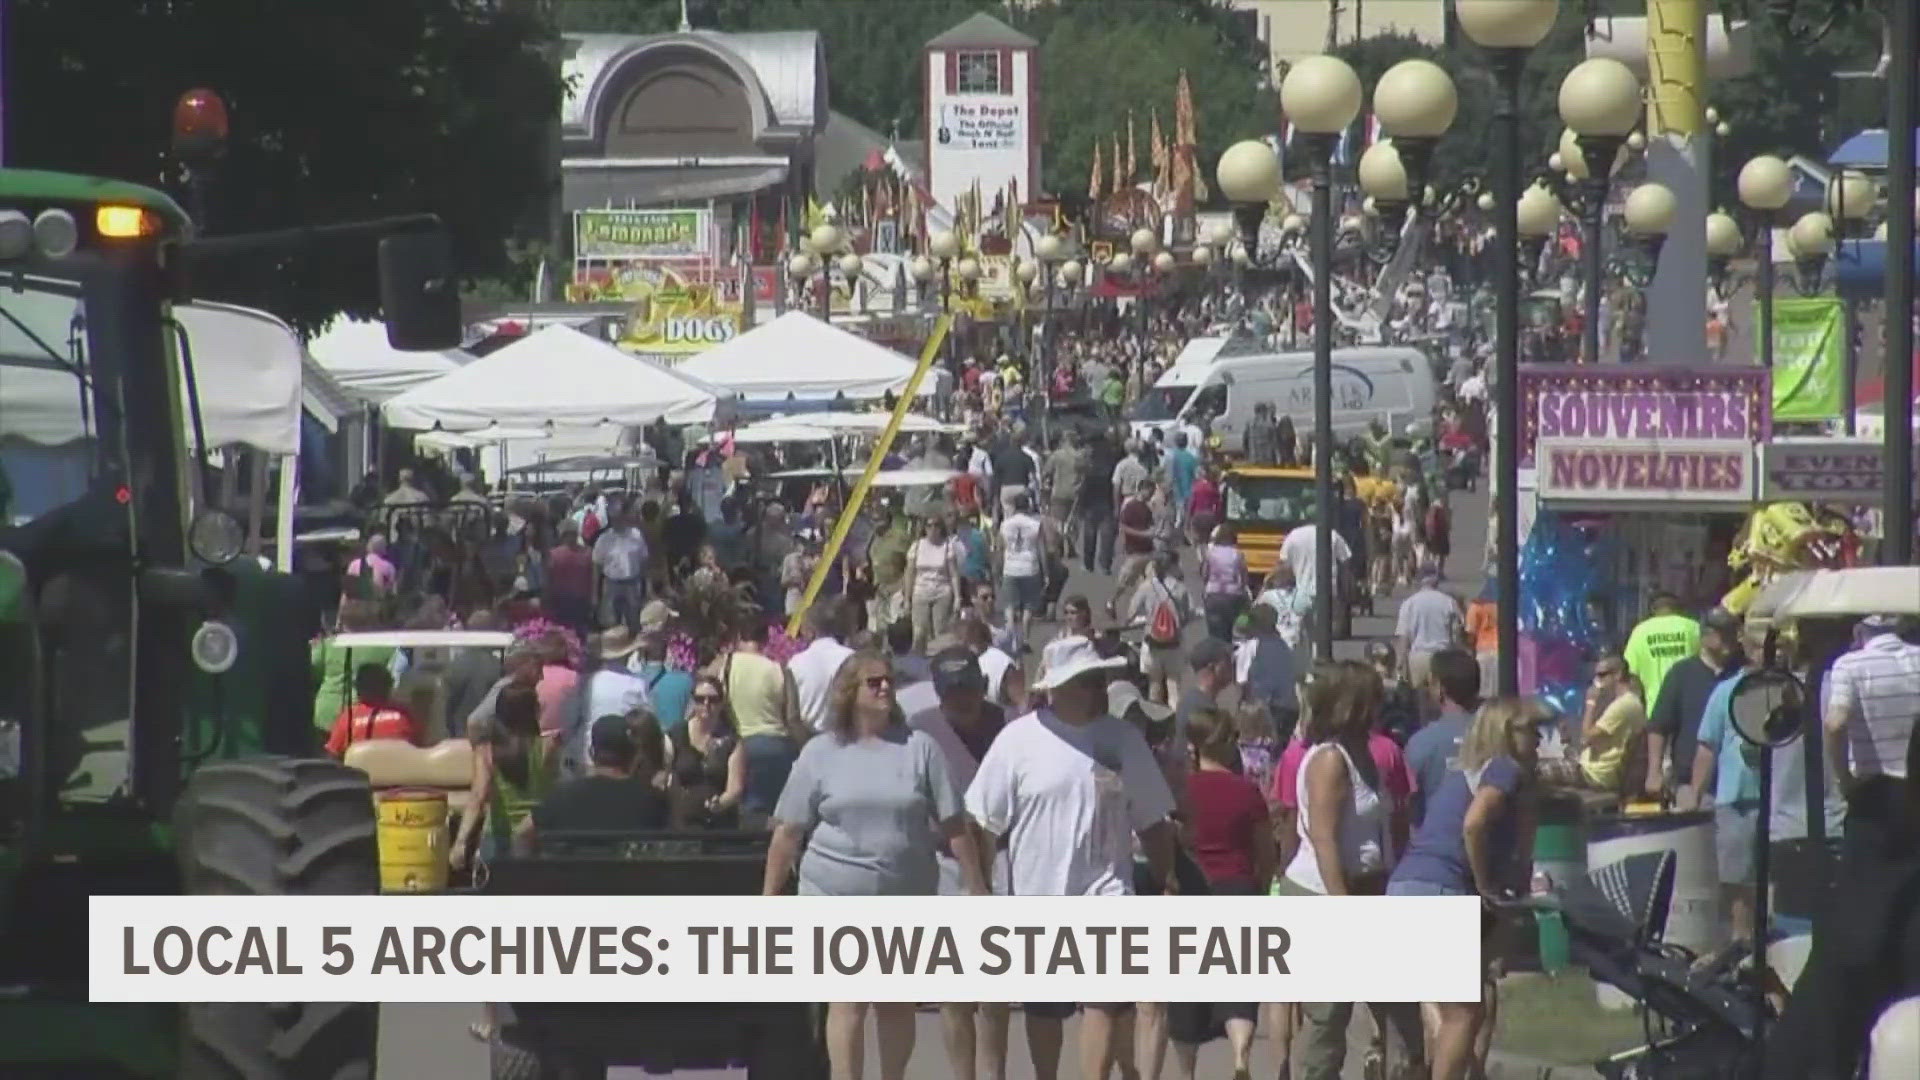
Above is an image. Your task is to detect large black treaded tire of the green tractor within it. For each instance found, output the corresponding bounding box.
[175,757,380,1080]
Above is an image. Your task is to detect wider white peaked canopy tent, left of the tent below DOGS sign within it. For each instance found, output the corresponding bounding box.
[380,327,732,432]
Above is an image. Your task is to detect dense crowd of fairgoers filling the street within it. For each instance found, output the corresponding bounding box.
[299,274,1920,1080]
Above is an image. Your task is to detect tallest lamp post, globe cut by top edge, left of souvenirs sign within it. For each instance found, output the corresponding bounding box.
[1453,0,1559,694]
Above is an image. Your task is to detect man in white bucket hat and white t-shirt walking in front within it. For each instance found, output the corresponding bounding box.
[966,638,1179,1076]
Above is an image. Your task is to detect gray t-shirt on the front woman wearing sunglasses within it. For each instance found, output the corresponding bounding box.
[774,726,962,896]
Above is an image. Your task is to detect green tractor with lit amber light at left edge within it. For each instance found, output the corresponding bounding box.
[0,169,461,1080]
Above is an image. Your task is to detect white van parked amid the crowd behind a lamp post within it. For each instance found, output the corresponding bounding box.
[1129,346,1438,452]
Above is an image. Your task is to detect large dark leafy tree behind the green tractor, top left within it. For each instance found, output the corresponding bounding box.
[6,0,561,331]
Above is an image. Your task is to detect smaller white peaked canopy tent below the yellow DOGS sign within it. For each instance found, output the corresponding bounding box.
[676,311,945,402]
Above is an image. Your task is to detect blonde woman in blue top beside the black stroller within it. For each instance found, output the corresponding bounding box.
[1386,698,1540,1080]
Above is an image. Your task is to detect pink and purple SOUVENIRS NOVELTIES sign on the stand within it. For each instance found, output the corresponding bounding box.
[1519,365,1772,503]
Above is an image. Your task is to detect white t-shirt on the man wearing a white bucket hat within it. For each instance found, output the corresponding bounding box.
[966,709,1173,896]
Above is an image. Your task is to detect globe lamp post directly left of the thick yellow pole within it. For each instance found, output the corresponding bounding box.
[1559,56,1640,363]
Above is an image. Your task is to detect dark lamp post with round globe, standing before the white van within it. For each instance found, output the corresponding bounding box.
[1282,56,1361,659]
